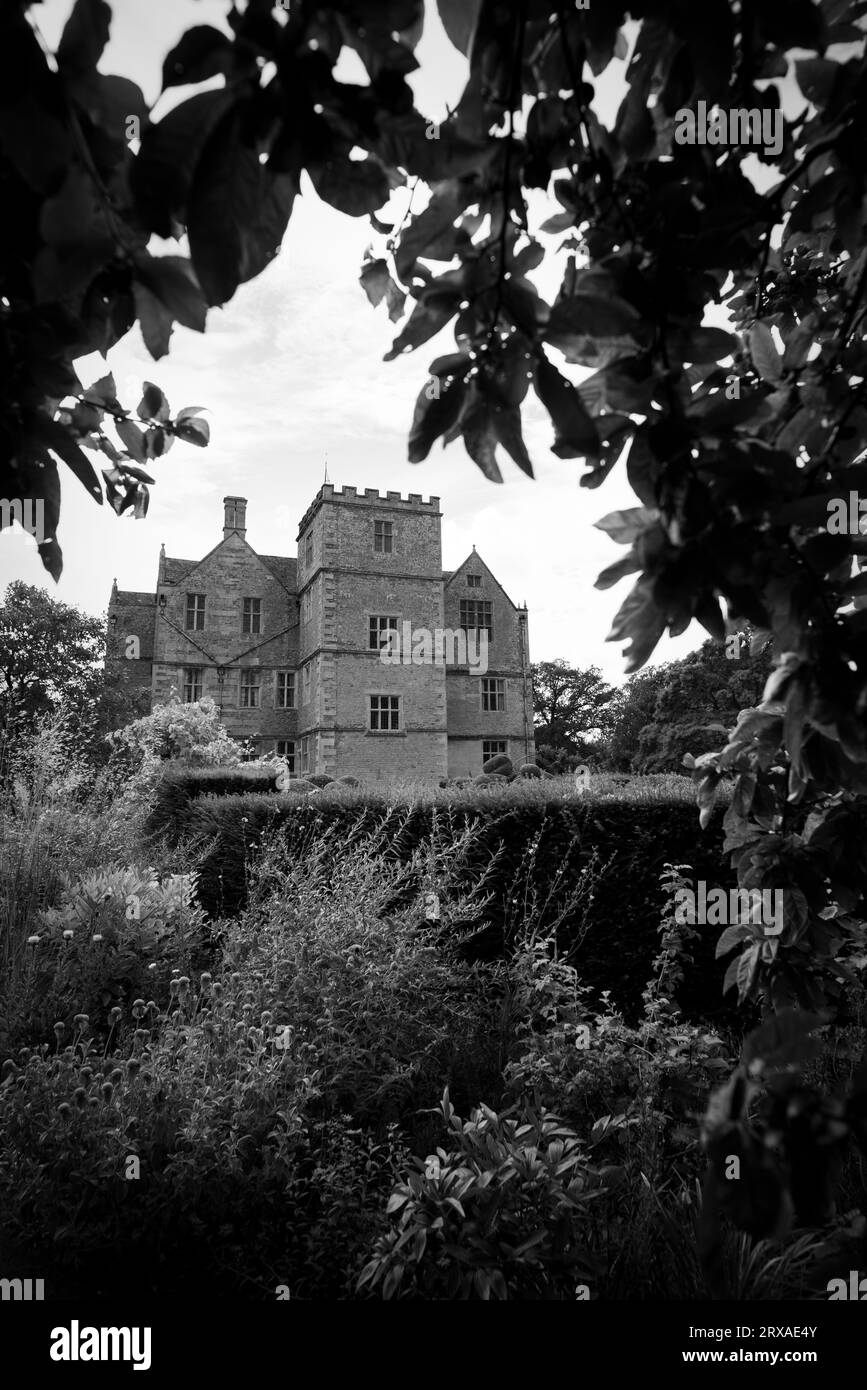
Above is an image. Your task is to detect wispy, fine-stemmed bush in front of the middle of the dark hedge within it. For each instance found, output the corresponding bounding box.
[225,828,499,1130]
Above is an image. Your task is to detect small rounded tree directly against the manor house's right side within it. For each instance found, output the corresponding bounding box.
[532,657,616,771]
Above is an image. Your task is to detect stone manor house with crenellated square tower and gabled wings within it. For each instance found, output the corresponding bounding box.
[106,482,534,780]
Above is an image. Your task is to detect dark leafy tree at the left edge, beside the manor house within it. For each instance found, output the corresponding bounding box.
[0,580,104,737]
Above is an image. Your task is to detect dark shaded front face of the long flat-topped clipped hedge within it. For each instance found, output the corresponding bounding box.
[174,795,735,1020]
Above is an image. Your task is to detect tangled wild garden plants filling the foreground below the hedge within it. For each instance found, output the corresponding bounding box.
[0,731,867,1300]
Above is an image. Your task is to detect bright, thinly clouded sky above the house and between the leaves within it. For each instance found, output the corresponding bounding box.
[0,0,800,684]
